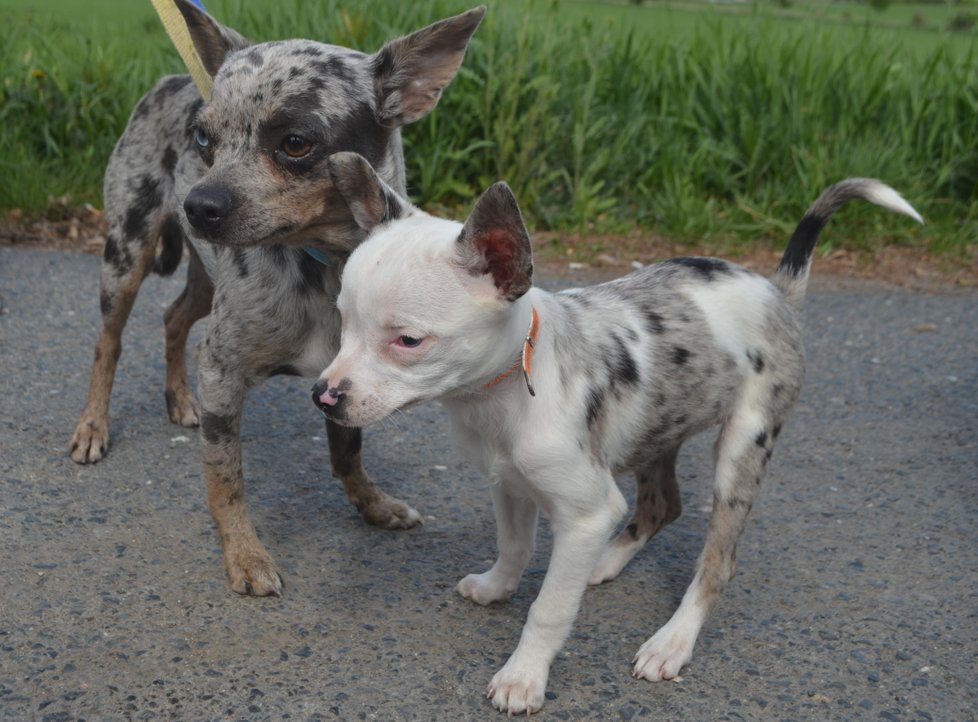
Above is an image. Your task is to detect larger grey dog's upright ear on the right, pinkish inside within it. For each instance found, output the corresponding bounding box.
[370,5,486,128]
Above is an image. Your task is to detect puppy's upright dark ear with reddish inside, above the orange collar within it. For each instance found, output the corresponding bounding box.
[457,182,533,301]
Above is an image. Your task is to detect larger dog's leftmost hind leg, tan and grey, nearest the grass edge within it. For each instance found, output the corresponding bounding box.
[71,224,158,464]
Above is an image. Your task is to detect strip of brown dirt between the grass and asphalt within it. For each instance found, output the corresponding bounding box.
[0,198,978,293]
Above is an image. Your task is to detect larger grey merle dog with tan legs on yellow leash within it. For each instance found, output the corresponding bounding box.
[71,0,485,595]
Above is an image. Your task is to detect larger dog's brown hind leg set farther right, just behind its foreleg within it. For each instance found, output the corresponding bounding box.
[163,244,214,426]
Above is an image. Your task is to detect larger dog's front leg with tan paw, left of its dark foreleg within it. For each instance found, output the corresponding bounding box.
[197,352,282,597]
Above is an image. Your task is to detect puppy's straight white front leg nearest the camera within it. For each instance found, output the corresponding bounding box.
[488,474,627,715]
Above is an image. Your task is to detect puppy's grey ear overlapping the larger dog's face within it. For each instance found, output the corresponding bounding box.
[326,153,411,233]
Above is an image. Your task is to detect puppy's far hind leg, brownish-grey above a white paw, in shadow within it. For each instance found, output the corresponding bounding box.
[588,446,682,584]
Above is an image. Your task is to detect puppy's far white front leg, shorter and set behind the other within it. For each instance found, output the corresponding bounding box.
[455,483,538,605]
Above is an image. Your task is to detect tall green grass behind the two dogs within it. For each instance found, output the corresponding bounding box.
[0,0,978,253]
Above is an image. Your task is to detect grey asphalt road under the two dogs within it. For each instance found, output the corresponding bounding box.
[0,248,978,721]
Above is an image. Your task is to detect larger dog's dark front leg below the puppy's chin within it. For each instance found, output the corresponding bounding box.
[326,419,421,529]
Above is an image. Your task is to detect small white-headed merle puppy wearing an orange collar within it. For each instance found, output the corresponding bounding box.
[313,153,920,714]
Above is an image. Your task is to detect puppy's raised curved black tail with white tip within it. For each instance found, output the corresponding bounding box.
[773,178,924,307]
